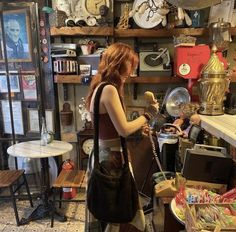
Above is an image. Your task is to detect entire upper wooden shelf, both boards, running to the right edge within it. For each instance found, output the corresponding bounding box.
[50,27,236,38]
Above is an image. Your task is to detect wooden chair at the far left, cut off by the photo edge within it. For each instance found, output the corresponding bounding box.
[0,170,33,226]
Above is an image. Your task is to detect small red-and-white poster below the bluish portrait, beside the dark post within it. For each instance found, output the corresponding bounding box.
[21,74,37,100]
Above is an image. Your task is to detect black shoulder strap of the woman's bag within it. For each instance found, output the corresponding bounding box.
[93,82,129,166]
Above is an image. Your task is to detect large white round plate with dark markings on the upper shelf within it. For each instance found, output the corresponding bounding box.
[133,0,162,29]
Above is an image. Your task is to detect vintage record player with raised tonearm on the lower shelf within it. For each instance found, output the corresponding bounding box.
[139,48,172,76]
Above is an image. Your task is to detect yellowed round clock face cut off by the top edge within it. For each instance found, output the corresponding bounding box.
[84,0,110,16]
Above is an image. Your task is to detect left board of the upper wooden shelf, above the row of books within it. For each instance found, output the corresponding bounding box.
[50,27,114,36]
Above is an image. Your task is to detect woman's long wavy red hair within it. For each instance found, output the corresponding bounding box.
[86,42,138,110]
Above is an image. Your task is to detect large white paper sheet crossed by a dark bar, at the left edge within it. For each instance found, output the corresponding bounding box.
[1,100,24,135]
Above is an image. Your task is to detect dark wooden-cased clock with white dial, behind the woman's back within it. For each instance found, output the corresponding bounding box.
[77,127,93,170]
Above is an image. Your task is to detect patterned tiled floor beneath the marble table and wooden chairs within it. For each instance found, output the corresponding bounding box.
[0,191,153,232]
